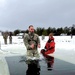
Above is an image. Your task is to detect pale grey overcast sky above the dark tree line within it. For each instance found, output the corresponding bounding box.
[0,0,75,31]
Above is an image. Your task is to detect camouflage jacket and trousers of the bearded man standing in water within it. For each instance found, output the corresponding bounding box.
[24,33,40,58]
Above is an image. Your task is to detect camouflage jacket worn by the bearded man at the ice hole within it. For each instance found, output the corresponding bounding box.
[23,33,40,50]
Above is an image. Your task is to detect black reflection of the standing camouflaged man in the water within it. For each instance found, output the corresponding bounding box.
[26,60,40,75]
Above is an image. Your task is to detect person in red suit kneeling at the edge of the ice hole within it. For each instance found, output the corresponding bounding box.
[41,33,55,56]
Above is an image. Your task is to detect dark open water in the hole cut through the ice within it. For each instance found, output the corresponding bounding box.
[6,56,75,75]
